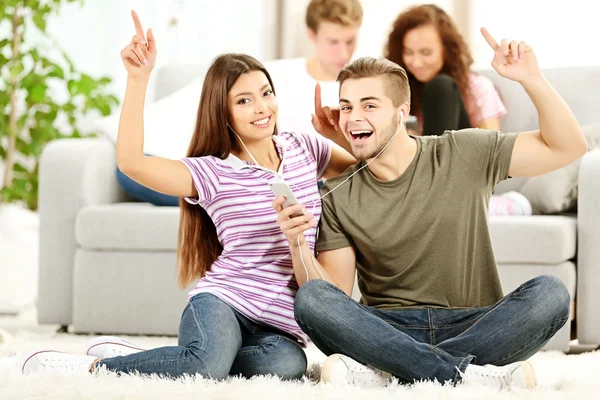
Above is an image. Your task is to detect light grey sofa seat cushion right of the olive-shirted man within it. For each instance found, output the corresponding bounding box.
[490,215,577,264]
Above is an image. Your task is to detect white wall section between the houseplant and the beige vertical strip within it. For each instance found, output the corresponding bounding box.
[41,0,277,98]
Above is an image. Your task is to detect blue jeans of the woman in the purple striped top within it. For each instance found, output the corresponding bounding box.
[97,293,307,380]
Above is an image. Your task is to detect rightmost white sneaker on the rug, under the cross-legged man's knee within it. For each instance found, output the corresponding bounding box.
[461,361,537,390]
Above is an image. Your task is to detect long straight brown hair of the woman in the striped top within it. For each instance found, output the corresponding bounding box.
[177,53,275,288]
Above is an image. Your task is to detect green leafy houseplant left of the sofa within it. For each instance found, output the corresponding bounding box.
[0,0,119,210]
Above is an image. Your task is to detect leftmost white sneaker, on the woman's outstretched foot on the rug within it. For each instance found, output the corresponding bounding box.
[18,350,96,374]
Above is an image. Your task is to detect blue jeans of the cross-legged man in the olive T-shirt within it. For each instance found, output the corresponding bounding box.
[294,275,570,383]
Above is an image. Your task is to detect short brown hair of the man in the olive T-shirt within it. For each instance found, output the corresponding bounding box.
[337,57,410,107]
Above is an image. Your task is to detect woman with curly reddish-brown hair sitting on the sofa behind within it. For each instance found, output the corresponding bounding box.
[385,4,506,135]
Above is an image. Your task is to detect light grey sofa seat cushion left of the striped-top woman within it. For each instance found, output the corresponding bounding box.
[75,203,179,251]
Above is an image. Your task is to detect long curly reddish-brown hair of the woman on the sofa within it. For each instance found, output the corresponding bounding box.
[384,4,475,119]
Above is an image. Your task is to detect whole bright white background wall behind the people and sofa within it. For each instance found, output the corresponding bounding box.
[15,0,600,104]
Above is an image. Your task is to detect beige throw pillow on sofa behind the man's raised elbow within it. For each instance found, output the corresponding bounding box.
[519,124,600,214]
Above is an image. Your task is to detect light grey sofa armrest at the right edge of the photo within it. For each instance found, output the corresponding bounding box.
[577,150,600,344]
